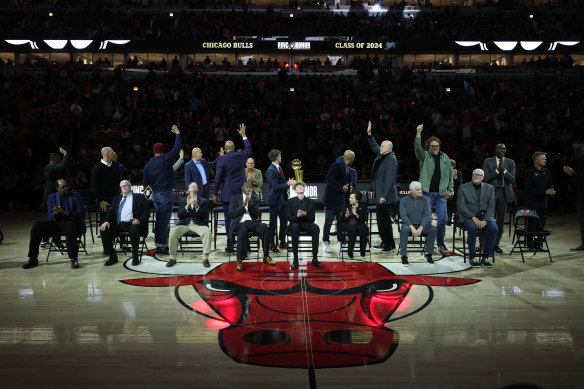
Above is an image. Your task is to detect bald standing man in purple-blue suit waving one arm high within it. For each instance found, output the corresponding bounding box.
[213,123,251,252]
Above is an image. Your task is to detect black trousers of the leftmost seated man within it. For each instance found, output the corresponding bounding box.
[28,220,82,259]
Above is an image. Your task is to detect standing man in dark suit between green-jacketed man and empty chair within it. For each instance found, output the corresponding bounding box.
[483,143,515,254]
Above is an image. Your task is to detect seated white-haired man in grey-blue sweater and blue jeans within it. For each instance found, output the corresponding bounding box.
[399,181,438,266]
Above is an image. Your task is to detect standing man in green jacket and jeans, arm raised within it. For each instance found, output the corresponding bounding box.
[414,124,454,252]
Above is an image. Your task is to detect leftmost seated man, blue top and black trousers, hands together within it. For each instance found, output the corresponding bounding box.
[22,180,85,269]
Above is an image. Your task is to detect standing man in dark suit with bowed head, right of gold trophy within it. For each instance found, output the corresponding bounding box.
[322,150,355,253]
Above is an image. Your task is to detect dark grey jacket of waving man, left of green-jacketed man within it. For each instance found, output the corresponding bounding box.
[367,136,399,204]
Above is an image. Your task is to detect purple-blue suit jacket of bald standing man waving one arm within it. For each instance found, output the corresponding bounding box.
[213,138,251,203]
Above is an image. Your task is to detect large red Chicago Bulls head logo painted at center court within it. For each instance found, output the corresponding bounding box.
[122,261,478,369]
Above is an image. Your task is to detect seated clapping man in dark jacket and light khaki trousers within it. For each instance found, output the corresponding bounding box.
[166,182,211,267]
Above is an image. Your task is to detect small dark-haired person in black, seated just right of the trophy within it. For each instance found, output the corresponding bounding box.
[342,190,369,258]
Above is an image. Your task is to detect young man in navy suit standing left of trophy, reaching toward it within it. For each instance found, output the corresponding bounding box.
[266,149,296,253]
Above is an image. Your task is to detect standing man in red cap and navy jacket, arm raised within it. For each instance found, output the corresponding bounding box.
[143,125,182,254]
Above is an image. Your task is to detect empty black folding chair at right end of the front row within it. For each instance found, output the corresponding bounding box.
[509,208,552,262]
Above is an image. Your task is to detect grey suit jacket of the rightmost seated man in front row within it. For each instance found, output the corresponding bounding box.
[456,181,495,223]
